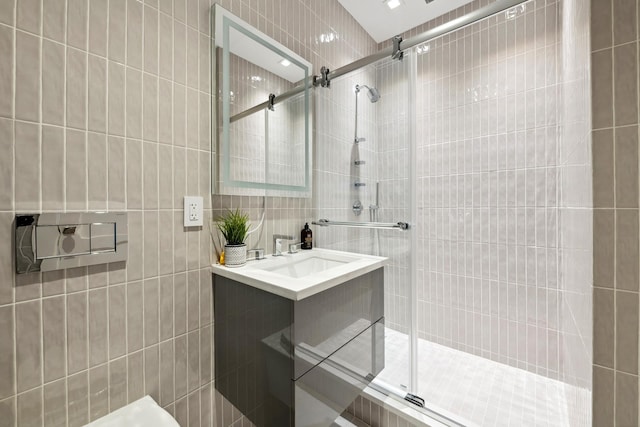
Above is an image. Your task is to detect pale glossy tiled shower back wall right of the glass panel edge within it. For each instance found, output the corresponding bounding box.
[417,1,561,378]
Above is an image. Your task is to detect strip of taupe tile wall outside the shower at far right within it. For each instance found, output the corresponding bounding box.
[591,0,640,427]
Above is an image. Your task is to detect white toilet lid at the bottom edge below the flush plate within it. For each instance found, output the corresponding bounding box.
[86,396,180,427]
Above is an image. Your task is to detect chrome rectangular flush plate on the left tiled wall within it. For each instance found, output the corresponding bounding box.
[15,212,128,274]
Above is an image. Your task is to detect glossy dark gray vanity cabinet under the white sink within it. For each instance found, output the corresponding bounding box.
[213,268,384,427]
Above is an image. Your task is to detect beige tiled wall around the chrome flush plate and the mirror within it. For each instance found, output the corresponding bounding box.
[0,0,375,426]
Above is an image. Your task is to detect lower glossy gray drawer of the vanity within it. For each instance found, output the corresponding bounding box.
[294,319,384,427]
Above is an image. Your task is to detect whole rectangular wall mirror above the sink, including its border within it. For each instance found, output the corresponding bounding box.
[212,4,311,197]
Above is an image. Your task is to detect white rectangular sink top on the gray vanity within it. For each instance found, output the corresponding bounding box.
[212,248,387,301]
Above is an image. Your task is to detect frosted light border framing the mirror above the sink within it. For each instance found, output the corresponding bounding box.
[211,4,312,198]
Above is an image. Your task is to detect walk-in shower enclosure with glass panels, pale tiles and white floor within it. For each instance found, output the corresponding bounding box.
[313,0,592,426]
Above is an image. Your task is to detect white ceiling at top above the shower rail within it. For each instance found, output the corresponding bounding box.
[338,0,473,43]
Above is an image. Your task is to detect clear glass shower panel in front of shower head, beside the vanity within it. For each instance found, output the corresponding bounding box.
[313,52,416,395]
